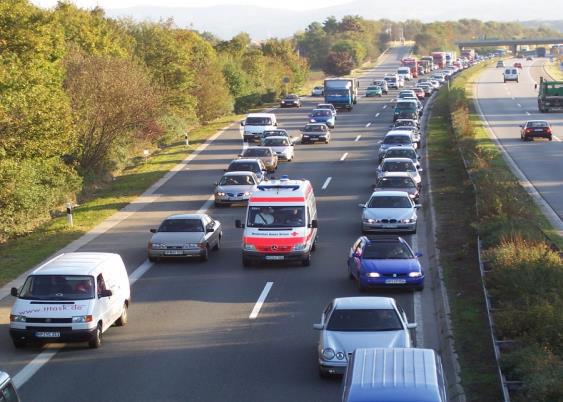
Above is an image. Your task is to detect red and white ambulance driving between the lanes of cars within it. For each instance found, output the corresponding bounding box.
[236,176,318,267]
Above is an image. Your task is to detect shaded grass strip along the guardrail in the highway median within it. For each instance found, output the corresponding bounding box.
[427,90,500,401]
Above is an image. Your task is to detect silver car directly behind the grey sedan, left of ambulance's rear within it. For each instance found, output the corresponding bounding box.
[213,172,260,207]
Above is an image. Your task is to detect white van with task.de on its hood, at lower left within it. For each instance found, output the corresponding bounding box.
[10,252,131,348]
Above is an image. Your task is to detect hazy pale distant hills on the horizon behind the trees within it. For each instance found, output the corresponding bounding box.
[106,0,562,40]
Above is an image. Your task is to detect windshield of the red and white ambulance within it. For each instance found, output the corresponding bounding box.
[247,206,305,228]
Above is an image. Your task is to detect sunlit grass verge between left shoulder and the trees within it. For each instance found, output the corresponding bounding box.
[0,115,242,286]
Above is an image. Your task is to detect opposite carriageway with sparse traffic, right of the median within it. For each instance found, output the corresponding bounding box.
[475,59,563,231]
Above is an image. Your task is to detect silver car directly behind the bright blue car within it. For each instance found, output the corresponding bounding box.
[358,191,420,234]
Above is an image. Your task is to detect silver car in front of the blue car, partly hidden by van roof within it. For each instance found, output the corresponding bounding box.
[313,297,416,377]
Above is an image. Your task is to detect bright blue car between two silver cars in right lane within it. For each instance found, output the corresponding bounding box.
[348,236,424,291]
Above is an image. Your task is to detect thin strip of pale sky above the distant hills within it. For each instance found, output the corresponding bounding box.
[31,0,350,10]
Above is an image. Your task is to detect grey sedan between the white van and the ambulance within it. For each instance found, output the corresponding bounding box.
[148,214,223,262]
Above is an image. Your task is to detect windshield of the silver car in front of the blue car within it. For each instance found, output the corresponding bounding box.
[326,309,403,332]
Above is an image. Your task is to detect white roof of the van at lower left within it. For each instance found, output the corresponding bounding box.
[31,252,117,275]
